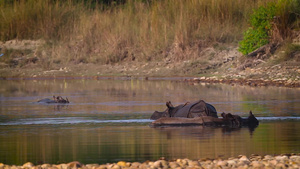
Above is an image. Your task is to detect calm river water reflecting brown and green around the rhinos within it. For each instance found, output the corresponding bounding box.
[0,79,300,165]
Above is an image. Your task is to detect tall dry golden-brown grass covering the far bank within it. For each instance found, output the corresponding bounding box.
[0,0,274,63]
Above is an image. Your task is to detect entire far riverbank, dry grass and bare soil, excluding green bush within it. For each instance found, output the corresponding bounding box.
[0,0,300,87]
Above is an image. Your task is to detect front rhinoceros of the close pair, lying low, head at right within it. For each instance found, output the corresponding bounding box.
[151,111,259,127]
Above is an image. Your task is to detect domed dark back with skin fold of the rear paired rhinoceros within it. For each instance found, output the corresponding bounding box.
[173,100,218,118]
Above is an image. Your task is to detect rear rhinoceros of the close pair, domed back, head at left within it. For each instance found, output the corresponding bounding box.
[150,100,218,120]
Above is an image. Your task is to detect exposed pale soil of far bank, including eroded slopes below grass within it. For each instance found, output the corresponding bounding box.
[0,39,300,87]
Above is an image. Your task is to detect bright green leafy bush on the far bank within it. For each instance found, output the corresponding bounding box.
[239,3,276,55]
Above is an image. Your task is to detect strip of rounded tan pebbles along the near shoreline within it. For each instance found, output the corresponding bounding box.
[0,154,300,169]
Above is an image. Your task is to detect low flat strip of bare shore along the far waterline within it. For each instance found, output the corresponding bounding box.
[0,55,300,88]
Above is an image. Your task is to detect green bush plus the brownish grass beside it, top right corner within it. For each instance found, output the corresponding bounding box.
[239,0,300,55]
